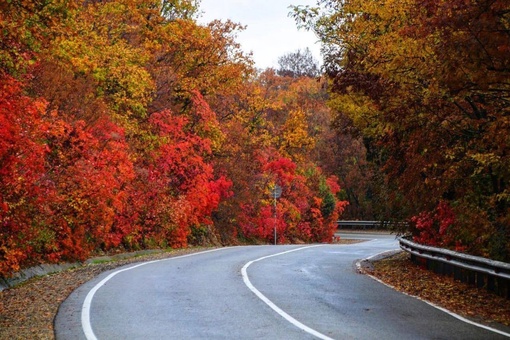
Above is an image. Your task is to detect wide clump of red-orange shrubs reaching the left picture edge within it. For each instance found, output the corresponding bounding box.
[0,76,137,274]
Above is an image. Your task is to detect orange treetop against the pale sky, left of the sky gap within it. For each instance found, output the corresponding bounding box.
[149,15,250,110]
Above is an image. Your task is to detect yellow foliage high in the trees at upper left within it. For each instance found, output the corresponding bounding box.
[49,1,155,129]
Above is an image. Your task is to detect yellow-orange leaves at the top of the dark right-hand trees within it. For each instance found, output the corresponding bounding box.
[347,0,433,86]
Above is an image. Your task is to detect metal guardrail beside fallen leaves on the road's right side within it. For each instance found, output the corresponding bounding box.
[399,237,510,298]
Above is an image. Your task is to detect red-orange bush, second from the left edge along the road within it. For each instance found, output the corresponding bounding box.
[43,117,134,259]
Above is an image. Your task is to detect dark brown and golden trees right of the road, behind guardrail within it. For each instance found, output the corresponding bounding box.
[294,0,510,261]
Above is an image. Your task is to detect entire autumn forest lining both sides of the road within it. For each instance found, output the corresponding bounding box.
[0,0,510,276]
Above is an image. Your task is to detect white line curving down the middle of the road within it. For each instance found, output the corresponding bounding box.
[241,245,333,340]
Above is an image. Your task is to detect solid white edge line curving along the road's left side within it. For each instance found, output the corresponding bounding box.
[81,247,230,340]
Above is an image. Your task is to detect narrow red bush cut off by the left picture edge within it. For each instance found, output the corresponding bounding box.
[0,75,52,274]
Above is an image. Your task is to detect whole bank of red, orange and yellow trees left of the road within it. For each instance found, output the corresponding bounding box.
[0,0,346,275]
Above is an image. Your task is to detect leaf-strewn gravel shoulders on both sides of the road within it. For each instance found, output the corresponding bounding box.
[0,240,510,340]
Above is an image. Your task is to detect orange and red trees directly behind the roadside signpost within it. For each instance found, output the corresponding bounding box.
[209,62,345,242]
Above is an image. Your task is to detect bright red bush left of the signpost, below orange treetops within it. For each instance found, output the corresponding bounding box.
[131,101,231,247]
